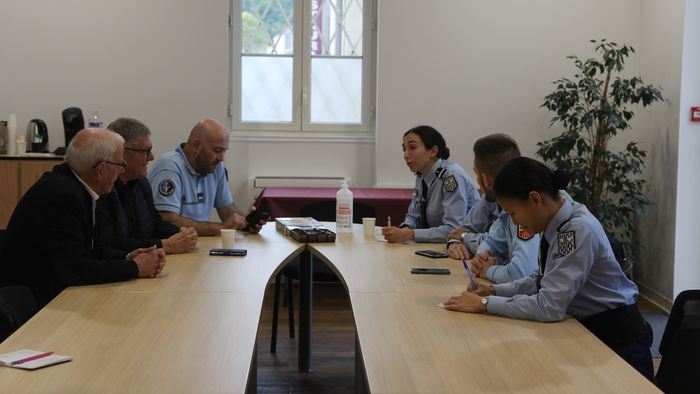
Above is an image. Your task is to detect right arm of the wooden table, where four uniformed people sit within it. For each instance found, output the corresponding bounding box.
[309,226,659,393]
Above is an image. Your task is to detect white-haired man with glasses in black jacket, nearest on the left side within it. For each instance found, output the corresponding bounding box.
[0,129,165,308]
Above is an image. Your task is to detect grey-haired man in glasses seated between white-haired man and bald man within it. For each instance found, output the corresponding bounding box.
[97,118,197,253]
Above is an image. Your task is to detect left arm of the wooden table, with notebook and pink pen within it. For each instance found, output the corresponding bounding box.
[0,224,305,393]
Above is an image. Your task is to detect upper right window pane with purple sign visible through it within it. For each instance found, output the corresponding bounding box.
[311,0,363,56]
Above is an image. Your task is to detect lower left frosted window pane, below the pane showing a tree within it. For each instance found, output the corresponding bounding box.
[241,56,292,122]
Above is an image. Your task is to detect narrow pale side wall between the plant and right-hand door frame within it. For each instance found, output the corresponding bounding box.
[634,0,684,307]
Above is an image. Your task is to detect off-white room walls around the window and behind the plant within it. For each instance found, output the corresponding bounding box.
[0,0,688,298]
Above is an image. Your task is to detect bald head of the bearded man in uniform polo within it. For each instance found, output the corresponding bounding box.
[182,119,229,174]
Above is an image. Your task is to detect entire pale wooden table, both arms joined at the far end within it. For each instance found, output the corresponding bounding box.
[0,224,658,393]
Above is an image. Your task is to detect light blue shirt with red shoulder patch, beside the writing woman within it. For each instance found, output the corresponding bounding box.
[477,212,540,283]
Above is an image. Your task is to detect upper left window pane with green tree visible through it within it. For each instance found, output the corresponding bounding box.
[241,0,294,55]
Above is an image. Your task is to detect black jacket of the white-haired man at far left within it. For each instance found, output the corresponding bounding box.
[0,163,138,308]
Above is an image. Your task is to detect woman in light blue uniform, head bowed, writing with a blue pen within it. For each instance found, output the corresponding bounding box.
[445,157,653,379]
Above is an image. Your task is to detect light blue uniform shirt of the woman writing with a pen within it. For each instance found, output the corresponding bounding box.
[487,193,638,321]
